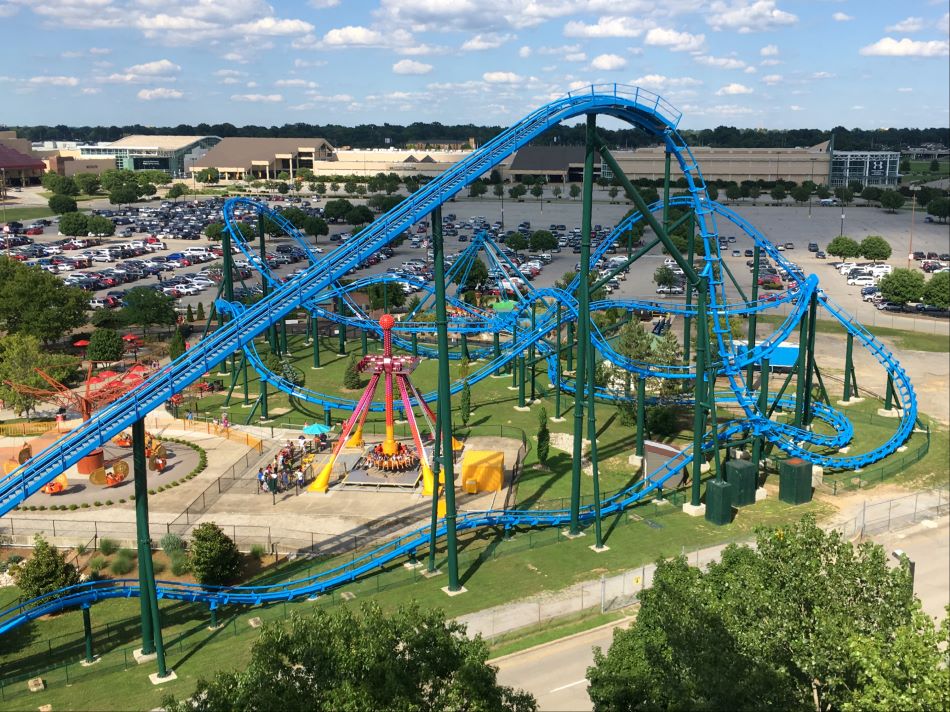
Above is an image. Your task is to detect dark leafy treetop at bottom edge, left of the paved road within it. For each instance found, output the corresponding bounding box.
[163,604,537,712]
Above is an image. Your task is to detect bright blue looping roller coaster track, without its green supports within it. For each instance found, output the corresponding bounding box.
[0,85,917,633]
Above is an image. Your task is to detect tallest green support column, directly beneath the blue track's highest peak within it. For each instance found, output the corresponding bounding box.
[570,114,597,535]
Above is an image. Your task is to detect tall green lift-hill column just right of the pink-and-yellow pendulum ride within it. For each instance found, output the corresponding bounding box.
[432,208,461,592]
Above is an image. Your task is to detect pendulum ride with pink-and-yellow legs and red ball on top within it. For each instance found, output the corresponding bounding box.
[308,314,435,494]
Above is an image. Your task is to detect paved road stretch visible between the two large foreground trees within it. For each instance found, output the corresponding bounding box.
[493,619,630,712]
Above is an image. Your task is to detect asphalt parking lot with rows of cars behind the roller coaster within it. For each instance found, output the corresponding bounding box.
[0,193,950,330]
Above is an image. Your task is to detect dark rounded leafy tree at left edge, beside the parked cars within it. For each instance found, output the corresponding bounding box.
[0,258,89,343]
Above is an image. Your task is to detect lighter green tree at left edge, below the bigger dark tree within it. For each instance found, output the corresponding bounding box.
[0,334,76,416]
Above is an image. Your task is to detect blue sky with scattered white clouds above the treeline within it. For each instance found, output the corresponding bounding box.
[0,0,950,128]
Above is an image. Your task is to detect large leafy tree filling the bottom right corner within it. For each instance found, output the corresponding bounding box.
[588,516,950,712]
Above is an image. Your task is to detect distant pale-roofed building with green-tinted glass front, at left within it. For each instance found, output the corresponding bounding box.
[78,136,221,177]
